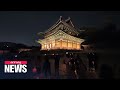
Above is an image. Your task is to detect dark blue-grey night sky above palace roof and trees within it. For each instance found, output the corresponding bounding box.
[0,11,120,46]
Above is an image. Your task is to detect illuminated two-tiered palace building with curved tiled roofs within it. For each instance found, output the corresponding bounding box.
[37,16,84,50]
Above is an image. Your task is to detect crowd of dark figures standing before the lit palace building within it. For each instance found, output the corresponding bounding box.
[33,53,97,79]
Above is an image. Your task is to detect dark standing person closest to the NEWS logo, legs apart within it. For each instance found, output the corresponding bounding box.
[43,56,51,77]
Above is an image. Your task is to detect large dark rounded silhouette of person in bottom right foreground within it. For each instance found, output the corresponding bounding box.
[99,64,113,79]
